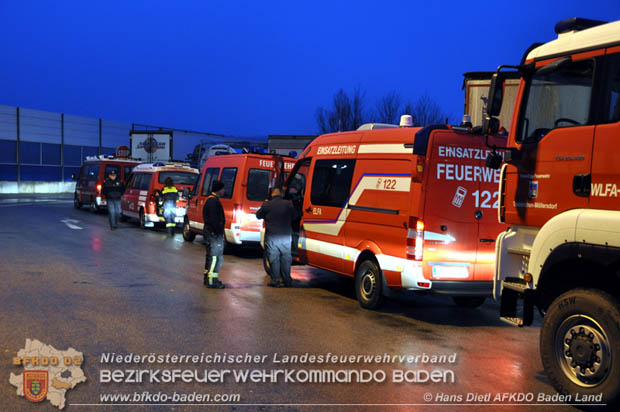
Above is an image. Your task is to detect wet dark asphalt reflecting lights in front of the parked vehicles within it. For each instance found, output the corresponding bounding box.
[0,198,588,411]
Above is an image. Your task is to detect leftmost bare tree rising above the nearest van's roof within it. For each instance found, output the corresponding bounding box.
[315,85,365,133]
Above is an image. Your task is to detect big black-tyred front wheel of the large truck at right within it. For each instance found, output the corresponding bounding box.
[540,289,620,405]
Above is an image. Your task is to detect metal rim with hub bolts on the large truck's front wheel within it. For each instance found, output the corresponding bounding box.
[555,315,612,388]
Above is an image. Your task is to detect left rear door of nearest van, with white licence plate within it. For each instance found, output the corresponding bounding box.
[422,130,482,281]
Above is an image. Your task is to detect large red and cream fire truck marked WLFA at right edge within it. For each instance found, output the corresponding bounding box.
[484,18,620,404]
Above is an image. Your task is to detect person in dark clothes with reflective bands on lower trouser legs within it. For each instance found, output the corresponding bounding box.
[202,180,225,289]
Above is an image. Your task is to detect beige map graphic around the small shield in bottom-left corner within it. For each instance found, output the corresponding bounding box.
[9,339,86,409]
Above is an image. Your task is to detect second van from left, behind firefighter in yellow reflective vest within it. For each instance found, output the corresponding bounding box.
[121,162,198,232]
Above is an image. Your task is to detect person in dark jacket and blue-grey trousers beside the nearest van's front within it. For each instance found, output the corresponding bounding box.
[256,188,297,288]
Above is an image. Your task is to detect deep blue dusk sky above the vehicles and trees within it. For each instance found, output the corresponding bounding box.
[0,0,620,136]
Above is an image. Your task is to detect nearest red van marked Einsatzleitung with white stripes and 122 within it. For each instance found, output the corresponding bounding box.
[284,117,505,308]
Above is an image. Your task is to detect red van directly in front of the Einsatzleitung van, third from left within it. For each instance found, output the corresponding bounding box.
[183,153,295,245]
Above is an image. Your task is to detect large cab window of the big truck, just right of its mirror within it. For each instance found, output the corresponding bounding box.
[517,60,594,142]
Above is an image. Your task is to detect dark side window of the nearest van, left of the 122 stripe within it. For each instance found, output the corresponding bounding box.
[310,159,355,207]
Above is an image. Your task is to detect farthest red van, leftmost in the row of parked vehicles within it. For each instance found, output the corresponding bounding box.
[71,155,140,212]
